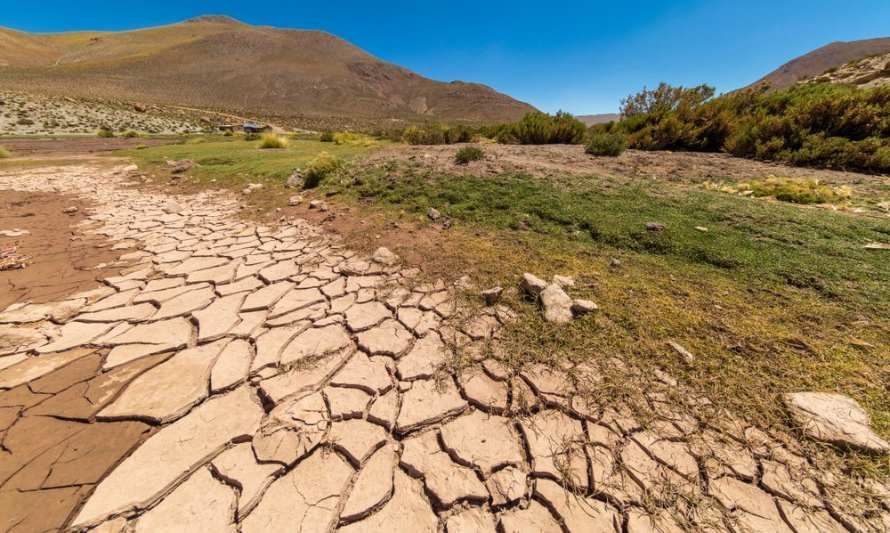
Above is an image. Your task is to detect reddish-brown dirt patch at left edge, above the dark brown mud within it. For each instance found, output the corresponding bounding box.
[0,191,120,309]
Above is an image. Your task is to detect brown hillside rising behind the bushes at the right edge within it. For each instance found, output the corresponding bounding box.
[751,37,890,89]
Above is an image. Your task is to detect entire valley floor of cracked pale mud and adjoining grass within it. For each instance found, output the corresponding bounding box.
[0,140,890,532]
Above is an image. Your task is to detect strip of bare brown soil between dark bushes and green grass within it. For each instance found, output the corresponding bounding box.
[367,144,890,188]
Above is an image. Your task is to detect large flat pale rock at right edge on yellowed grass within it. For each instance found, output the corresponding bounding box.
[784,392,890,453]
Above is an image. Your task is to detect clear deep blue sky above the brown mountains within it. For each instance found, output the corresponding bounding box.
[0,0,890,114]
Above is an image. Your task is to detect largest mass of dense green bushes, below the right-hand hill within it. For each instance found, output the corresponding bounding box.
[608,84,890,173]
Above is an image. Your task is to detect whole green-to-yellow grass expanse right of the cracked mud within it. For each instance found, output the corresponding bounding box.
[322,162,890,475]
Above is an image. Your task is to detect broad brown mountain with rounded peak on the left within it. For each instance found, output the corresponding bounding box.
[0,16,534,122]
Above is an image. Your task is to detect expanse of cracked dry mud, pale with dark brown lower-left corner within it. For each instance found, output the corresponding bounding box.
[0,166,890,533]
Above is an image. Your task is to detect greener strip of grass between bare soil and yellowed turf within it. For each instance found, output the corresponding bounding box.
[330,166,890,312]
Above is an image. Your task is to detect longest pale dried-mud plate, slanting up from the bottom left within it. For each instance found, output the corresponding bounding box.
[72,387,263,527]
